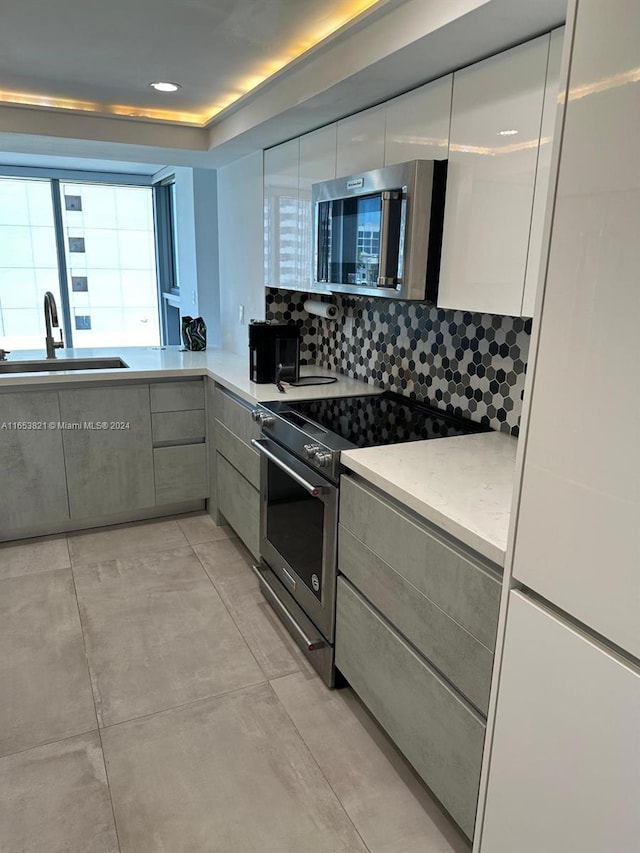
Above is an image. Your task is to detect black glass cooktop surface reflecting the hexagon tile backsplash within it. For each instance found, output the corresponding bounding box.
[288,391,489,447]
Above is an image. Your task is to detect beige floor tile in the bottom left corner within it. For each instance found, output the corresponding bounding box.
[0,733,119,853]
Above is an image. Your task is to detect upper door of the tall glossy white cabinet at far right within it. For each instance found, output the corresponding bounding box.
[513,13,640,659]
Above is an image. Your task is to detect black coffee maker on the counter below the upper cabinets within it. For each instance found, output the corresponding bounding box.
[249,320,300,384]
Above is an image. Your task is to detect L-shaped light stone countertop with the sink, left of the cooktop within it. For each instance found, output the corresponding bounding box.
[0,346,382,403]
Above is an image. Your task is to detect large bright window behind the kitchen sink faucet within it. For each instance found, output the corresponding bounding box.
[0,178,160,350]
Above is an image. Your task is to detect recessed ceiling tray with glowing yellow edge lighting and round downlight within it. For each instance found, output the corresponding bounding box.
[0,0,398,126]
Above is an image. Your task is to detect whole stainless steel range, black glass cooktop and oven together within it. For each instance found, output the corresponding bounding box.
[252,392,487,686]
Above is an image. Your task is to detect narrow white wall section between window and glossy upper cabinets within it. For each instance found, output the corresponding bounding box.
[218,151,265,358]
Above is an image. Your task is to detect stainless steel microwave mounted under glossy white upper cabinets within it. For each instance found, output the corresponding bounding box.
[311,160,447,304]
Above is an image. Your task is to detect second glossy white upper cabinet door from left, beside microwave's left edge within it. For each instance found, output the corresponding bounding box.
[299,124,337,292]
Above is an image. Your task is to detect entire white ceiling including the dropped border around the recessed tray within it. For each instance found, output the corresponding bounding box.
[0,0,567,173]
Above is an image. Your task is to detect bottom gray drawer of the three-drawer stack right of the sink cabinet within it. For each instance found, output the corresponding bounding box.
[153,444,208,504]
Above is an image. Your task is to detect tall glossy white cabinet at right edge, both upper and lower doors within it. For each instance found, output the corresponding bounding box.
[477,0,640,853]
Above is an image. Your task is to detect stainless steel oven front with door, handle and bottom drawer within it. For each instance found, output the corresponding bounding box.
[252,437,338,686]
